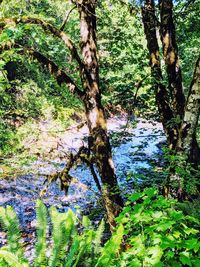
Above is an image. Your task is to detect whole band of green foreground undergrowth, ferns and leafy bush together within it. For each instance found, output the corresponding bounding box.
[0,188,200,267]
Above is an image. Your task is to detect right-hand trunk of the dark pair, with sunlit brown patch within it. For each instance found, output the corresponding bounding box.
[159,0,185,120]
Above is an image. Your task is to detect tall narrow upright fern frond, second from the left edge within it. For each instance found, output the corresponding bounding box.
[34,200,48,267]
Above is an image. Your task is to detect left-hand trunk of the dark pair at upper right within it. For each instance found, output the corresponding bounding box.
[142,0,178,149]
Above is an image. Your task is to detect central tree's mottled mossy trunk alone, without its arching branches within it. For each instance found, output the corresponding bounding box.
[78,0,123,229]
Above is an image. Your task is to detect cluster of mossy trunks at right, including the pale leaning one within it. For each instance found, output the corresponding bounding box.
[142,0,200,165]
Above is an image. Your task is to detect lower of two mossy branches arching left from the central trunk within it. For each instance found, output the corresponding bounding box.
[0,42,84,100]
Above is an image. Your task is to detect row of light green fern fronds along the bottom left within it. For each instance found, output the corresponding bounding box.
[0,200,123,267]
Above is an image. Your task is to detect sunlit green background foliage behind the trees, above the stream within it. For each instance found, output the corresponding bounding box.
[0,0,200,157]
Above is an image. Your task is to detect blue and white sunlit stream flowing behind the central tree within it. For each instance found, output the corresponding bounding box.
[0,116,165,258]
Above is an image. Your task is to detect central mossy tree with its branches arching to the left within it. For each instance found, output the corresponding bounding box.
[0,0,123,226]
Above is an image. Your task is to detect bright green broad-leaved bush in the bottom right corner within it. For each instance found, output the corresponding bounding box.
[117,188,200,267]
